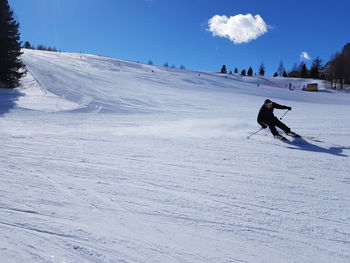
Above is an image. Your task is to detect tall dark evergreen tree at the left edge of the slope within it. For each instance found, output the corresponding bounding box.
[0,0,25,88]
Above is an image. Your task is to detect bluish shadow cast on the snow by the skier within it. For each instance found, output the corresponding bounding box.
[286,138,350,157]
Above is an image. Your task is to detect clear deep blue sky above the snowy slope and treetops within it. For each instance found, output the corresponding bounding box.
[9,0,350,75]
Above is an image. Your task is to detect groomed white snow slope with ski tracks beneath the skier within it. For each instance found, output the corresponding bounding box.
[0,50,350,263]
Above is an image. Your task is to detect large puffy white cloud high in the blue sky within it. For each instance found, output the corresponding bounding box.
[208,14,270,44]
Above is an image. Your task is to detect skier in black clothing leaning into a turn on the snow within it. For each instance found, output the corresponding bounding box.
[257,99,300,140]
